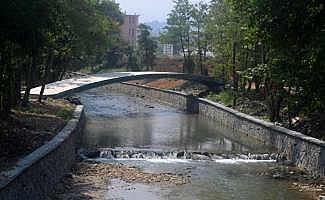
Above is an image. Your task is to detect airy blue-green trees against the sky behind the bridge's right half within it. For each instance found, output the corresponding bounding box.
[160,0,208,75]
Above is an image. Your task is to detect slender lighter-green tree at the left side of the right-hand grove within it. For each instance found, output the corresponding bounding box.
[206,0,251,106]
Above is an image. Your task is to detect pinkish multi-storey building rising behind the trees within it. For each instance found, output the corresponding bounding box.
[121,15,139,47]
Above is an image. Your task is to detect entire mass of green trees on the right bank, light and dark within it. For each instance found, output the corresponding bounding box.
[205,0,325,123]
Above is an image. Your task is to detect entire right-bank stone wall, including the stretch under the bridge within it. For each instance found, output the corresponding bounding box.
[107,83,325,176]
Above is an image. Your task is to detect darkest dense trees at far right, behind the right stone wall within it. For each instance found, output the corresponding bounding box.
[230,0,325,122]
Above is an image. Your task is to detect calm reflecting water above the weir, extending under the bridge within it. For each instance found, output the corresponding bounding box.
[80,91,265,152]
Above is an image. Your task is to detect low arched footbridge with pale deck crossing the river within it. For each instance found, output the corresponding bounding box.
[30,72,221,98]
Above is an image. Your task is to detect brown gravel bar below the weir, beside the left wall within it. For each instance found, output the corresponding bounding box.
[53,162,190,200]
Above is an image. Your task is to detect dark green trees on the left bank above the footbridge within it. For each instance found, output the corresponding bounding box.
[0,0,123,115]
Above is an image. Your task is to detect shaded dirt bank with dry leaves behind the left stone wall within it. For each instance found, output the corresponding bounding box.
[0,98,75,171]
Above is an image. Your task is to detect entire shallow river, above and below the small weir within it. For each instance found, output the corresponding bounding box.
[78,87,311,200]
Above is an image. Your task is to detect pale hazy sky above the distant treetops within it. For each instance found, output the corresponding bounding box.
[115,0,209,22]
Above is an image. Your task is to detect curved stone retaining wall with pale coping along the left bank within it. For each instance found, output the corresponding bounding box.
[0,106,85,200]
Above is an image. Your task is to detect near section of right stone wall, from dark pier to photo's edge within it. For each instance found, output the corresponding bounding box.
[196,99,325,176]
